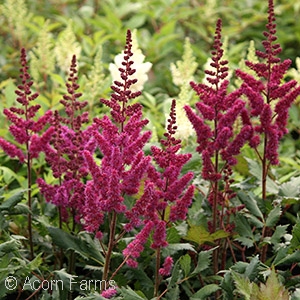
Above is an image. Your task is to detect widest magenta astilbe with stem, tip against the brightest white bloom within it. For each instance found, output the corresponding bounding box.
[83,31,151,288]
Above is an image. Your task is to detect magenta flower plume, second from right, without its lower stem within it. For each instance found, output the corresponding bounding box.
[184,19,253,182]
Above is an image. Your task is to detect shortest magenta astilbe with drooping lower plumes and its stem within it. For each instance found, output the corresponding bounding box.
[123,100,194,296]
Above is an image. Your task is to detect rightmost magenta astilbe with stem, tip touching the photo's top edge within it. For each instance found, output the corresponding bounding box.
[236,0,300,261]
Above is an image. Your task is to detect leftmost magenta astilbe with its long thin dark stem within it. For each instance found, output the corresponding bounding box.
[0,48,52,258]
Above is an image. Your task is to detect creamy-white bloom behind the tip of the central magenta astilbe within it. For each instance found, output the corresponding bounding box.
[109,30,152,92]
